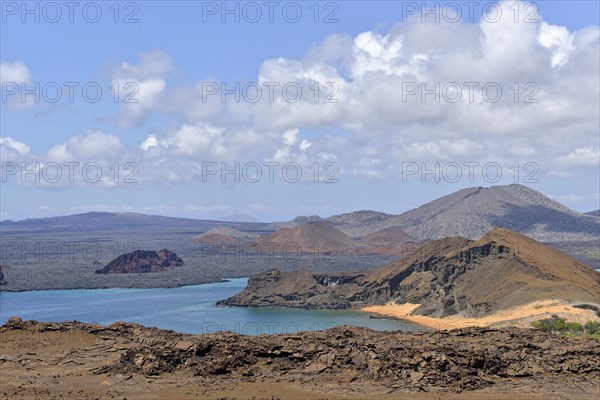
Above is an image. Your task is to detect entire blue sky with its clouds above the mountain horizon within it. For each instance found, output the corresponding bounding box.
[0,0,600,221]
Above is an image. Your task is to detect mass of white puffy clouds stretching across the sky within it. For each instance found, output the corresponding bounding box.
[0,1,600,219]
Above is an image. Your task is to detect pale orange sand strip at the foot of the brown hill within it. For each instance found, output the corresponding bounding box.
[361,300,599,329]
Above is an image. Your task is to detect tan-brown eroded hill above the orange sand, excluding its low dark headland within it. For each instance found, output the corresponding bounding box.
[367,228,600,316]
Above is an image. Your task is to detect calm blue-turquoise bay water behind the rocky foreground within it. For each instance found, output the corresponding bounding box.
[0,278,422,335]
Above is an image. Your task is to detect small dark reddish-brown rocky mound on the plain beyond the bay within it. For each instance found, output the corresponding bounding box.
[96,249,183,274]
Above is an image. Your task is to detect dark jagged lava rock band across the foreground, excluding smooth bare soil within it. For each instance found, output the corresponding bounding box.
[0,318,600,392]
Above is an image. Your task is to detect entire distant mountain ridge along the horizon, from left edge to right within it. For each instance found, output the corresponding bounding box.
[0,184,600,243]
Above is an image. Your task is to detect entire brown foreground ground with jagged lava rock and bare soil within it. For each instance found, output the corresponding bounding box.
[0,318,600,399]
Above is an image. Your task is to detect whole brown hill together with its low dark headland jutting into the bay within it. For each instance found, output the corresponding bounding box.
[223,228,600,317]
